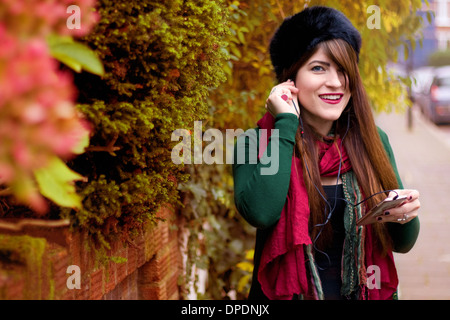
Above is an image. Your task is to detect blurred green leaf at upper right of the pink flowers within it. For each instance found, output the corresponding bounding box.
[47,37,105,76]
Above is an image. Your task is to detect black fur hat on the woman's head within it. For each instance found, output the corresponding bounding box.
[269,6,361,81]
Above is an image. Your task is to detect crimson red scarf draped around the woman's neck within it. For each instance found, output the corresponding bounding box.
[258,112,398,300]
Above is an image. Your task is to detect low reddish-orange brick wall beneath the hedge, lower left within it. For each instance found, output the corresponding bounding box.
[0,208,182,300]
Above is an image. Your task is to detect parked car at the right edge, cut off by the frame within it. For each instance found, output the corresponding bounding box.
[413,66,450,124]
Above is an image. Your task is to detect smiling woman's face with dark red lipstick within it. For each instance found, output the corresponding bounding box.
[295,48,351,135]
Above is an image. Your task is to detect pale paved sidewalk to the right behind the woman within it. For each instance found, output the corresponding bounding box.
[375,107,450,300]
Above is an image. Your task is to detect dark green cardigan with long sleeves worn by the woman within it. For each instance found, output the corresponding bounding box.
[233,113,419,253]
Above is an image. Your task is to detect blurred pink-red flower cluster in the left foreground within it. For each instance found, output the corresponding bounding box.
[0,0,96,213]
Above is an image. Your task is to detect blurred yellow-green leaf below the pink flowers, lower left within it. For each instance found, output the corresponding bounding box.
[34,157,84,208]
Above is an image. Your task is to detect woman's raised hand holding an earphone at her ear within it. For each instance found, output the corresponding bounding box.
[266,80,300,118]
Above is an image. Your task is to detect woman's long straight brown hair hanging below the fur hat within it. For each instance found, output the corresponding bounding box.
[281,39,398,253]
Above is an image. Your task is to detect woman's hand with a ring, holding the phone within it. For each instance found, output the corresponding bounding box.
[377,189,420,224]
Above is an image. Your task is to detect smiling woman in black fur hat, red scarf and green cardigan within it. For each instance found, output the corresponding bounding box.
[233,7,420,299]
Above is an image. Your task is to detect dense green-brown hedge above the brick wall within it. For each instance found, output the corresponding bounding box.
[61,0,228,247]
